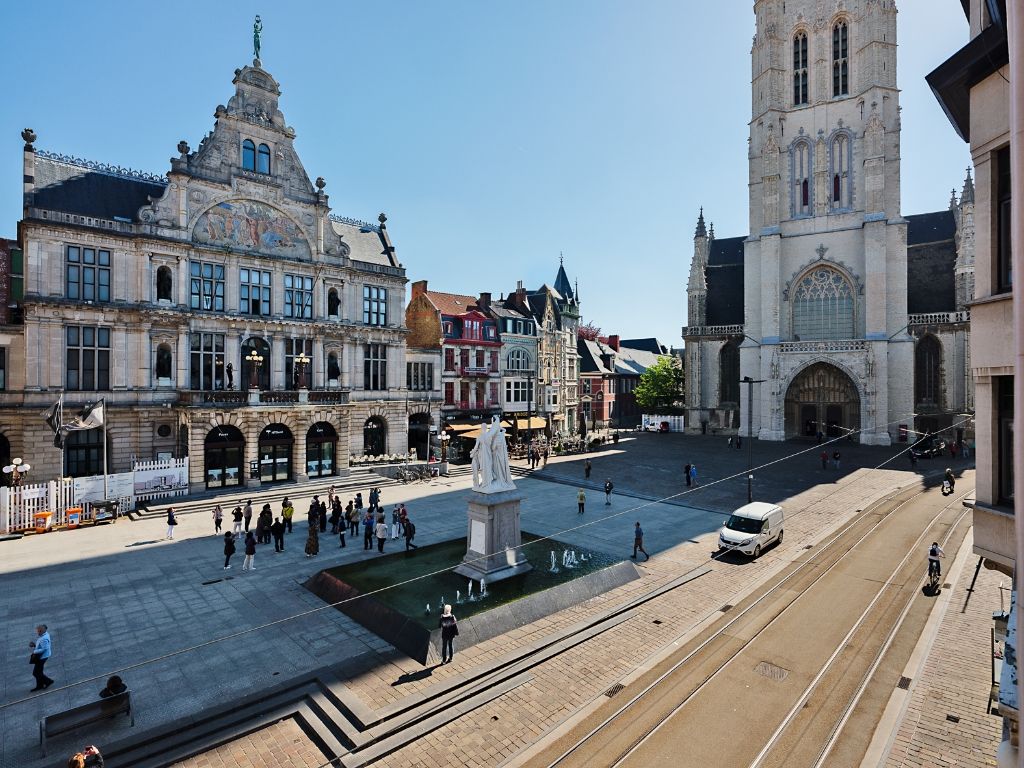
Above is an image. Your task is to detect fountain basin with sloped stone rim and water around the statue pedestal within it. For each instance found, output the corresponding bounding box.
[305,531,640,664]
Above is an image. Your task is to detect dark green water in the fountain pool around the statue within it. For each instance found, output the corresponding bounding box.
[328,532,622,630]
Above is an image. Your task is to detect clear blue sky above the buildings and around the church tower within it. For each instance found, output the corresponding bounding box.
[0,0,970,346]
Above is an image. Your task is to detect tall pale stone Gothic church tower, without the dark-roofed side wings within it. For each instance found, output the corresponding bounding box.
[740,0,913,444]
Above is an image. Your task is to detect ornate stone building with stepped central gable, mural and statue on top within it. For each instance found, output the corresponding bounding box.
[0,51,411,487]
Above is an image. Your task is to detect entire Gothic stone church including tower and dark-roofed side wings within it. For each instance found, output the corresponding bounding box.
[683,0,974,444]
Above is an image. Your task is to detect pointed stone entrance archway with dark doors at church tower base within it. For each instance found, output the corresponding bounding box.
[785,362,860,438]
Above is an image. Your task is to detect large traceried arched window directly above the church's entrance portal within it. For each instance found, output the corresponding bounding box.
[793,266,854,341]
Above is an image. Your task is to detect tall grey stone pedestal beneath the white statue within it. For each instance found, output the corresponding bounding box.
[455,490,532,584]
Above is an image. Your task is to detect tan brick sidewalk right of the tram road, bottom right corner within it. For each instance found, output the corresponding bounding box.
[885,528,1010,768]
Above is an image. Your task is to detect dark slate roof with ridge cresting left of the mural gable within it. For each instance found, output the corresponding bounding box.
[32,153,167,221]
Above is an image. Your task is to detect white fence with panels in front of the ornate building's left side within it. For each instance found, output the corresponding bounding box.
[0,457,188,534]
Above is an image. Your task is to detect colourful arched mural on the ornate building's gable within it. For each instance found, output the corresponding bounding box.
[193,200,309,257]
